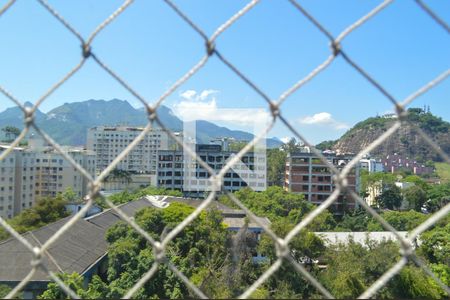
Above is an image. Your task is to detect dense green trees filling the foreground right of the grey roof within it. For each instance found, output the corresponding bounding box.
[37,187,450,299]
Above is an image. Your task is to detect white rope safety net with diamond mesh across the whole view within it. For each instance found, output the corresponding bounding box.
[0,0,450,299]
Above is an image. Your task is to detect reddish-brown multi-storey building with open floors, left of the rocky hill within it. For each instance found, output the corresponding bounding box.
[284,153,359,214]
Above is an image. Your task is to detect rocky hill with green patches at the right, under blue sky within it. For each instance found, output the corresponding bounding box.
[332,108,450,161]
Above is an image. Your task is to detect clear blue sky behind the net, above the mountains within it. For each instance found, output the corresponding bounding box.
[0,0,450,143]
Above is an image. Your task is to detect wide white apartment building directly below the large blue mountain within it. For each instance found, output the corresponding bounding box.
[87,126,175,174]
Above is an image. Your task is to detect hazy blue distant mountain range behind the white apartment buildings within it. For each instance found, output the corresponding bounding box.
[0,99,282,148]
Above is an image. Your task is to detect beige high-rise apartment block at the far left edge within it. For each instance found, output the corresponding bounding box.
[0,138,95,218]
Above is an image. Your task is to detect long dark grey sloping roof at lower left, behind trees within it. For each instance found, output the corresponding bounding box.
[0,196,270,282]
